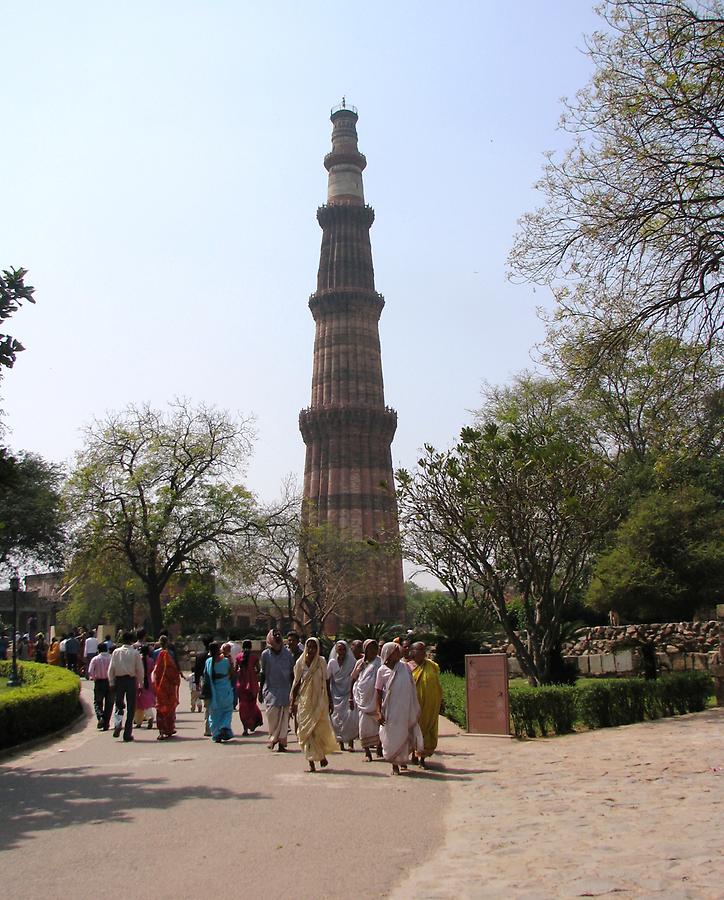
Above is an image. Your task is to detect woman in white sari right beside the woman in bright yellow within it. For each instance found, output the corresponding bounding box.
[375,642,423,775]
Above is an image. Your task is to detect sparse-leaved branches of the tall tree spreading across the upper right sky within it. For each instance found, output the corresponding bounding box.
[510,0,724,353]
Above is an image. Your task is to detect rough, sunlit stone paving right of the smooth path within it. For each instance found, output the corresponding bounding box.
[391,709,724,900]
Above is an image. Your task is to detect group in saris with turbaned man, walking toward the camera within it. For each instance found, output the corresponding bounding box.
[221,630,442,774]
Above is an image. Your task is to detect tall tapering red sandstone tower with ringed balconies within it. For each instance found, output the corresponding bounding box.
[299,100,404,624]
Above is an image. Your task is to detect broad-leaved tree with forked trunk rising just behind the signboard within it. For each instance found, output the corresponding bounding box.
[397,377,612,684]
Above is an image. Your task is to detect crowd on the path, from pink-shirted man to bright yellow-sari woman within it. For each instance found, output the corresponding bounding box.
[89,629,442,775]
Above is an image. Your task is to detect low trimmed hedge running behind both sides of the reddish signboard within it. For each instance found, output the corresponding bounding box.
[441,672,713,737]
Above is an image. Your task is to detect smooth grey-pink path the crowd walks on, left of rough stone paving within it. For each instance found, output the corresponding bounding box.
[0,682,452,900]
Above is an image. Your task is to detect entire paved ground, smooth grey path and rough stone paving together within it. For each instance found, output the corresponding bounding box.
[0,684,724,900]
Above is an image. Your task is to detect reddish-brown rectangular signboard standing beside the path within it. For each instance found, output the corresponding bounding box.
[465,653,510,735]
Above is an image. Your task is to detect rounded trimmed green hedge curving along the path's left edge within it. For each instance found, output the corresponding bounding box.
[0,662,80,748]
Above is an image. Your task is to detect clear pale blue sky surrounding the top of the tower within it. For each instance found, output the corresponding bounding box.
[0,0,598,500]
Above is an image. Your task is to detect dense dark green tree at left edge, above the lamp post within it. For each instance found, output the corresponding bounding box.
[0,447,65,567]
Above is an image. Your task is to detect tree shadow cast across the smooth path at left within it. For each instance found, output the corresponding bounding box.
[0,766,271,850]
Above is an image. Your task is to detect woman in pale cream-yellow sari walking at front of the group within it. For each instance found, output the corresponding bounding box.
[291,638,337,772]
